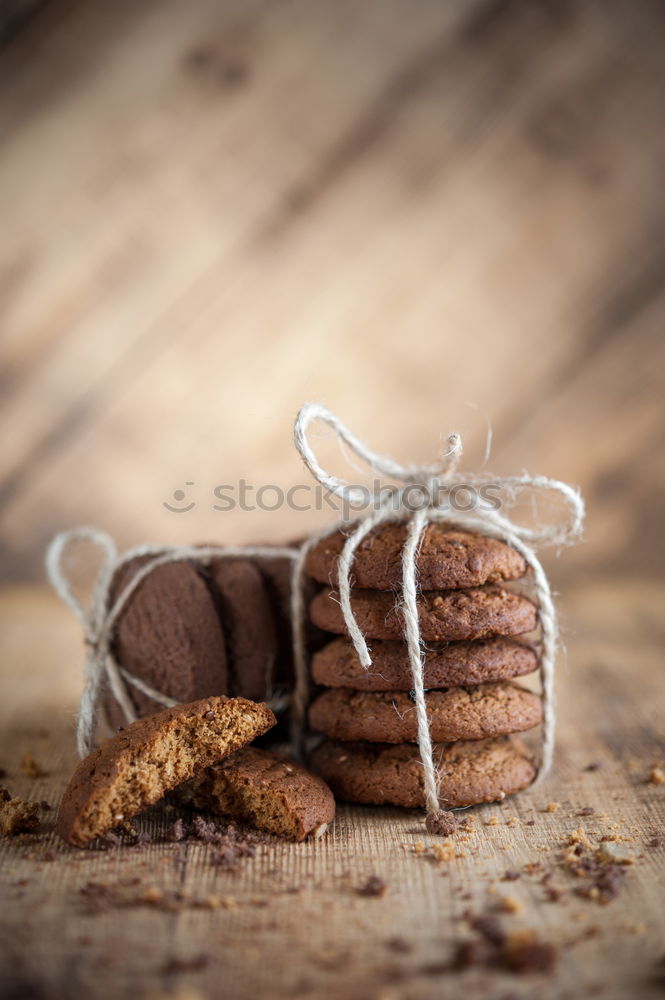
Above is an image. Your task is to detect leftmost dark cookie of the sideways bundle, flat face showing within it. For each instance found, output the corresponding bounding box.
[104,556,228,726]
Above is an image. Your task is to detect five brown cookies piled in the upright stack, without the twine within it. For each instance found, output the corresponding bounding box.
[307,524,542,808]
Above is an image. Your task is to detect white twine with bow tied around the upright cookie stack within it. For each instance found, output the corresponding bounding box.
[292,403,584,815]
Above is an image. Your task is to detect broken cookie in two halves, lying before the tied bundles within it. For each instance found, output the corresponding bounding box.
[56,696,335,847]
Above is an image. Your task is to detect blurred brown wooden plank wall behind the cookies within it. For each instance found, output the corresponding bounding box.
[0,0,665,581]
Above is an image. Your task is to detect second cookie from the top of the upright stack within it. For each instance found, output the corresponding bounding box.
[310,584,537,641]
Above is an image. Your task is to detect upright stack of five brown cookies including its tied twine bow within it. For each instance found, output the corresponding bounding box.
[293,404,584,832]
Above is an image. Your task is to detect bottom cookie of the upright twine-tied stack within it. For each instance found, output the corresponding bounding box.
[311,736,535,809]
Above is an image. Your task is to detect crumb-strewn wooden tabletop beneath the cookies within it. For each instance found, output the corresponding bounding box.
[0,579,665,1000]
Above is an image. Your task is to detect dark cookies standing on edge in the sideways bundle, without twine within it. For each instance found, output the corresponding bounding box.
[103,556,313,728]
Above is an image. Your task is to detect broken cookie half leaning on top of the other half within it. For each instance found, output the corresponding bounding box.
[56,696,275,847]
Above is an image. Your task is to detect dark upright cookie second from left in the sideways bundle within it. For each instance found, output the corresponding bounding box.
[209,558,277,700]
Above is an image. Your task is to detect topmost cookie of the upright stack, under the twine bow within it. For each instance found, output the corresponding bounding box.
[306,522,527,590]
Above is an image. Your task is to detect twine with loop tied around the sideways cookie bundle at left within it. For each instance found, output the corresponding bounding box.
[46,527,298,757]
